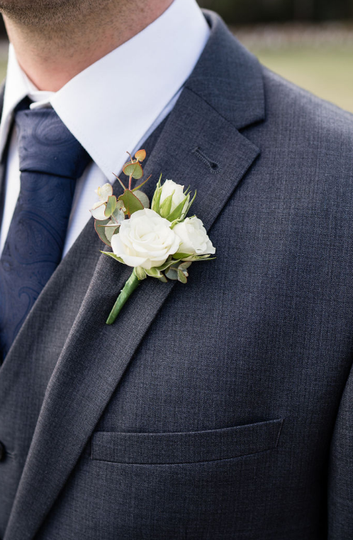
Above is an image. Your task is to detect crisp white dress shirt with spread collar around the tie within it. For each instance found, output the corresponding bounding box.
[0,0,209,255]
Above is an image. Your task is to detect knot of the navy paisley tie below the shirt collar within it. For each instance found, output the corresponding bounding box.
[15,108,90,180]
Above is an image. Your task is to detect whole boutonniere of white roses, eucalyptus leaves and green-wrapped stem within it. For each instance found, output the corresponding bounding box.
[90,150,216,324]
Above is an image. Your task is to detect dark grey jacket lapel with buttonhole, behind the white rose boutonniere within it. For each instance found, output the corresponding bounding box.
[4,16,264,540]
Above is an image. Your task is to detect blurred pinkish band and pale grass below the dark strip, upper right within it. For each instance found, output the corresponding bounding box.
[230,27,353,112]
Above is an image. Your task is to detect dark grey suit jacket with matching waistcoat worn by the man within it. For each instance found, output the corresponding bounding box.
[0,12,353,540]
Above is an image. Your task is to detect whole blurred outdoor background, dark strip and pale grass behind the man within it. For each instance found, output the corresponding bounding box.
[0,0,353,112]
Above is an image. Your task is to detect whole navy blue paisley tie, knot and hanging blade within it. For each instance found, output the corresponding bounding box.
[0,103,90,361]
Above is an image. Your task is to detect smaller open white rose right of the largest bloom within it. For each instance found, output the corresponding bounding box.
[173,216,216,255]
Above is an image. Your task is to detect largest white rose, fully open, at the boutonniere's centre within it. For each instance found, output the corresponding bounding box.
[111,208,180,270]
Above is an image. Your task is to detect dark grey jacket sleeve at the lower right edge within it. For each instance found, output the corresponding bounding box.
[328,360,353,540]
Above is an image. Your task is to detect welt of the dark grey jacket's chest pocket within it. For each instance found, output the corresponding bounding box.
[91,419,283,465]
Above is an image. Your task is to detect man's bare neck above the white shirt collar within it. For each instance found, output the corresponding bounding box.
[3,0,173,92]
